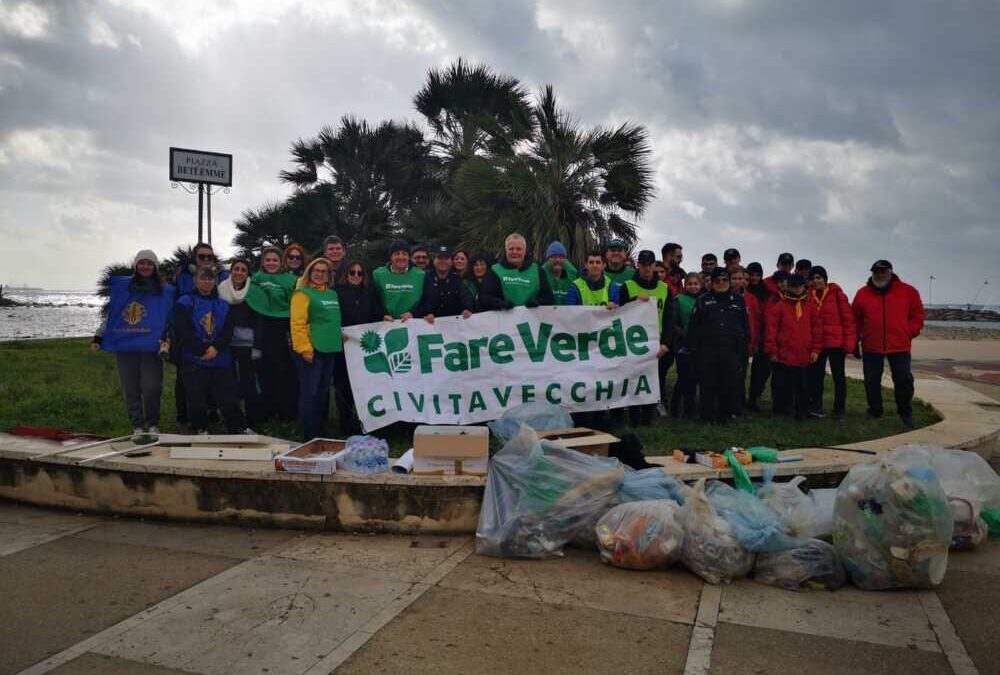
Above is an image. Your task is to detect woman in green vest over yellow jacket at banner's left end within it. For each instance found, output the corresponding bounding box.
[290,258,344,439]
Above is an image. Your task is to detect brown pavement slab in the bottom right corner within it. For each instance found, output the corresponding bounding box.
[937,570,1000,673]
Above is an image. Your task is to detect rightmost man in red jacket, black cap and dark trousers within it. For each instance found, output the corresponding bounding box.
[852,260,924,427]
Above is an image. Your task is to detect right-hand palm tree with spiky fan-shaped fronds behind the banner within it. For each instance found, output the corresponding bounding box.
[454,85,653,263]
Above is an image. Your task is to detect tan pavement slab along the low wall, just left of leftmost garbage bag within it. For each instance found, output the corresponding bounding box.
[279,533,472,582]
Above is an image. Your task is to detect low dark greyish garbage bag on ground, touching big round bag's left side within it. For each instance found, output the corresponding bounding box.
[753,539,847,591]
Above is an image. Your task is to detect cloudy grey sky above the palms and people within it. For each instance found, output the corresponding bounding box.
[0,0,1000,303]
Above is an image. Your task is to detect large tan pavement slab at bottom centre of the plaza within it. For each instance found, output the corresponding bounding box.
[337,587,691,675]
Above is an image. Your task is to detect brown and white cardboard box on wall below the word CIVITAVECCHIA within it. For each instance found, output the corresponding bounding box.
[413,425,490,476]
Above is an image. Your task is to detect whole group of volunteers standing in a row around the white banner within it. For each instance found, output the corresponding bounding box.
[91,234,924,438]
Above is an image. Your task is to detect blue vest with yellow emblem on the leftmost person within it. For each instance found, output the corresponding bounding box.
[101,276,176,353]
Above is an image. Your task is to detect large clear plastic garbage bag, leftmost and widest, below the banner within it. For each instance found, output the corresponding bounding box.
[476,426,625,558]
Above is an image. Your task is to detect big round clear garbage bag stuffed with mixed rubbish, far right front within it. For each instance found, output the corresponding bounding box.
[833,451,953,590]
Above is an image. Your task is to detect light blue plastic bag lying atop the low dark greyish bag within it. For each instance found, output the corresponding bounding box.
[706,481,801,553]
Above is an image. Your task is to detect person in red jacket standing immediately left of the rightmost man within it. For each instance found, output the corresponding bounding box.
[809,265,857,421]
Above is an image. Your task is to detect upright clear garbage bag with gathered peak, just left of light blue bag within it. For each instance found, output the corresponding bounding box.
[678,479,754,584]
